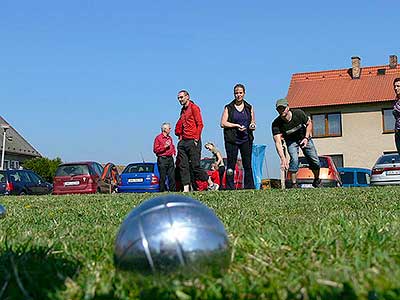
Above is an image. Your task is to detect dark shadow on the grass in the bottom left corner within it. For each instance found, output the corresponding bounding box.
[0,245,81,299]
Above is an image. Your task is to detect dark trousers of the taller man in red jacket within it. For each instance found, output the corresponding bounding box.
[177,140,208,186]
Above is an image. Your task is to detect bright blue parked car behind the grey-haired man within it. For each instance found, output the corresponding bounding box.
[118,162,160,193]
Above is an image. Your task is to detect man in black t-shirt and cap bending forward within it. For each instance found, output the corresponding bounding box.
[272,98,321,187]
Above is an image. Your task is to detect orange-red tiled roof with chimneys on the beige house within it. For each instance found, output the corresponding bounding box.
[287,55,400,108]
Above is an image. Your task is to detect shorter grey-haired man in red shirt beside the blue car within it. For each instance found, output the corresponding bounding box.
[153,123,176,192]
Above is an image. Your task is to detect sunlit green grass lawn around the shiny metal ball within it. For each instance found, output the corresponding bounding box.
[0,187,400,300]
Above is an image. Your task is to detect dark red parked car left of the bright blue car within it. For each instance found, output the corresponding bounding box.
[53,161,119,195]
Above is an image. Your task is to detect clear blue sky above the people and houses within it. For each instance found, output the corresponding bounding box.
[0,0,400,177]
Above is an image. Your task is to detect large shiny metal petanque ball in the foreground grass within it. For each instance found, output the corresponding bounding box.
[114,195,230,276]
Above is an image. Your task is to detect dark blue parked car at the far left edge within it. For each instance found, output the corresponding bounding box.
[0,170,53,195]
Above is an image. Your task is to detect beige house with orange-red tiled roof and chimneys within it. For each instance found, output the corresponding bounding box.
[287,55,400,168]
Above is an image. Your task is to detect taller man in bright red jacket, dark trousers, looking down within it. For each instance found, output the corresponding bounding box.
[175,90,218,192]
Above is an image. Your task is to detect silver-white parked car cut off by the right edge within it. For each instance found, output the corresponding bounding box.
[371,153,400,185]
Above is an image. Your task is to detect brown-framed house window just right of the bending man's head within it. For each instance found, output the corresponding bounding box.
[311,113,342,137]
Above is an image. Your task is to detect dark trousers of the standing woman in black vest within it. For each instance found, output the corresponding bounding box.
[225,141,254,190]
